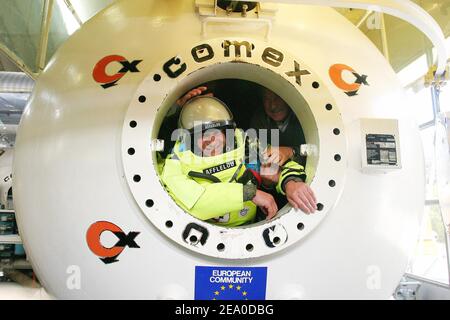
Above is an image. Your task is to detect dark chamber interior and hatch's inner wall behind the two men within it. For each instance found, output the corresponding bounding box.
[152,62,319,227]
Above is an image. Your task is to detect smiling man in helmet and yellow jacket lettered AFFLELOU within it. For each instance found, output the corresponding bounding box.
[161,96,312,227]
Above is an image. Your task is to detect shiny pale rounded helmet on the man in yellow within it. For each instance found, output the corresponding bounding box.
[178,96,235,133]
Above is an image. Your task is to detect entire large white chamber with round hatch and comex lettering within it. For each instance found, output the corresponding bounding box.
[13,0,424,299]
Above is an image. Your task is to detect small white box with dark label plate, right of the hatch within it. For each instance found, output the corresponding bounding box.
[360,119,402,173]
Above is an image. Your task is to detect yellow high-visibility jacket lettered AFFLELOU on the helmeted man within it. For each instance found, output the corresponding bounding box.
[161,130,303,227]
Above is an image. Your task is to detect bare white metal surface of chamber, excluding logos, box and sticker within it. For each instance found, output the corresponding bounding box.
[13,0,424,299]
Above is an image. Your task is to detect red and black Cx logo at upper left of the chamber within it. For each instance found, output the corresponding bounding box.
[92,55,142,89]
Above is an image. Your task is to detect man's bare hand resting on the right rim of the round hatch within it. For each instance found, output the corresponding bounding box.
[285,180,317,213]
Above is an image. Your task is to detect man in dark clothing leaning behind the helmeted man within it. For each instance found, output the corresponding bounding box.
[171,82,317,214]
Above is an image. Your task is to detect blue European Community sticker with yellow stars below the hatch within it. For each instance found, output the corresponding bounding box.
[195,266,267,300]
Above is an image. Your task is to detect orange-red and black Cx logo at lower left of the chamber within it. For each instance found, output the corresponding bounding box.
[86,221,140,264]
